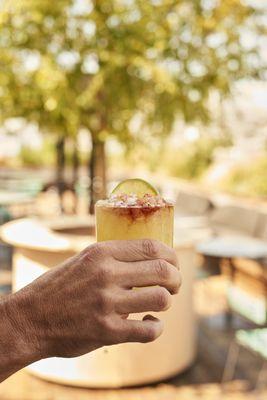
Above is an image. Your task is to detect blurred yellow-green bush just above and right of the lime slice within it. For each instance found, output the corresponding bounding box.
[163,137,231,179]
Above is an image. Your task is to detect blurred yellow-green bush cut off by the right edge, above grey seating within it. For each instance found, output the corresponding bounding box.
[221,158,267,197]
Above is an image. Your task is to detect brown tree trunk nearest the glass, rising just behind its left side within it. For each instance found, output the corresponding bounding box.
[89,138,106,214]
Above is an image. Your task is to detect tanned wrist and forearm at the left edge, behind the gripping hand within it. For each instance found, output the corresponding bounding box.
[0,294,39,382]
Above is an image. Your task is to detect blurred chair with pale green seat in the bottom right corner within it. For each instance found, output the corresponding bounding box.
[222,328,267,389]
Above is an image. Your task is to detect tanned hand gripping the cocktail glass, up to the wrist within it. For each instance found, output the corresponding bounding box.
[3,239,181,359]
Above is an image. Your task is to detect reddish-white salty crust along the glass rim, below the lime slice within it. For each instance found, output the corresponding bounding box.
[97,193,173,208]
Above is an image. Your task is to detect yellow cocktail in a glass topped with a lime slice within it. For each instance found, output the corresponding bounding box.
[96,179,174,246]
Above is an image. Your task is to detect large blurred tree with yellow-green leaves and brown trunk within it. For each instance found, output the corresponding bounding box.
[0,0,264,212]
